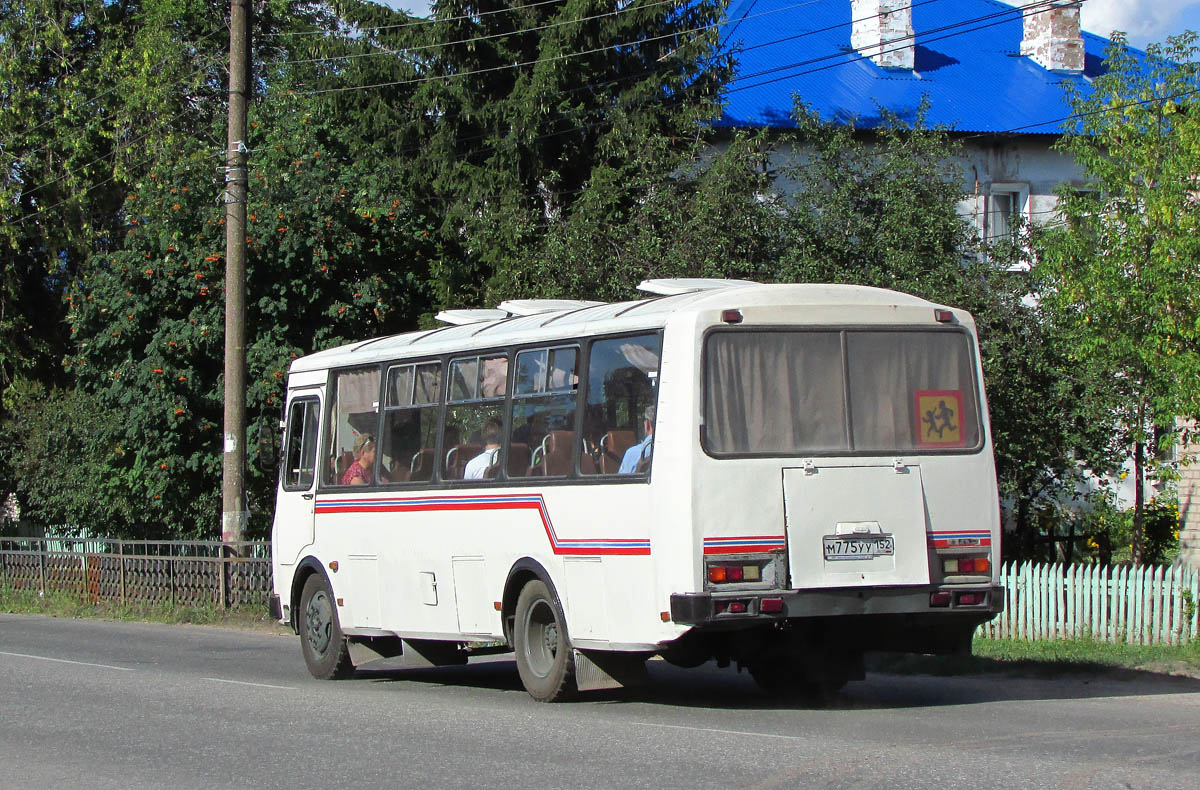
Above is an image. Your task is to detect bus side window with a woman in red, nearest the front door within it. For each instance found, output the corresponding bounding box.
[322,367,380,485]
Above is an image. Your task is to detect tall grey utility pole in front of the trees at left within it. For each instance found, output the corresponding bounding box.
[221,0,250,552]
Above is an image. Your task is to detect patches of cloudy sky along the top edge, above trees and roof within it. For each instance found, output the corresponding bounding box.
[382,0,1200,47]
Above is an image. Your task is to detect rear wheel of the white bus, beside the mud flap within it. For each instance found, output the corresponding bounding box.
[512,579,577,702]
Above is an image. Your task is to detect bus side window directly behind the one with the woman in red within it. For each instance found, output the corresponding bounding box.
[380,363,442,483]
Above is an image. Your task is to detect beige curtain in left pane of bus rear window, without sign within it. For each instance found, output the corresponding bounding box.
[704,331,846,455]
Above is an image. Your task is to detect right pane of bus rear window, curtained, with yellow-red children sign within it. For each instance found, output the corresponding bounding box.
[846,331,979,451]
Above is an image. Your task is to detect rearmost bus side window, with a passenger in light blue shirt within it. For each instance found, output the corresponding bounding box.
[580,335,662,474]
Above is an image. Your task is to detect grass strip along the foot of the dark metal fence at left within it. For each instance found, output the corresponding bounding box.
[0,589,278,630]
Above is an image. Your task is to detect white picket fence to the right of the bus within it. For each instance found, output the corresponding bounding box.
[976,562,1200,645]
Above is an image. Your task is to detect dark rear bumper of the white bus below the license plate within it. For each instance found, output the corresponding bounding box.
[671,585,1004,628]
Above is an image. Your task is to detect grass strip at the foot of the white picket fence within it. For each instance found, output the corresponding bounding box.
[868,639,1200,678]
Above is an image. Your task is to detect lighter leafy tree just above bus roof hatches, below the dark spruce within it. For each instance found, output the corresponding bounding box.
[518,133,786,300]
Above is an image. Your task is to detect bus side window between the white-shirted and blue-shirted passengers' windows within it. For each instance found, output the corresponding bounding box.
[505,346,580,478]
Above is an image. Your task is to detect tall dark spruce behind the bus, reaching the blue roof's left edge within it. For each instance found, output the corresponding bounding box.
[412,0,731,304]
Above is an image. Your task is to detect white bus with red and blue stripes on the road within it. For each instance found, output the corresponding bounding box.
[271,280,1002,701]
